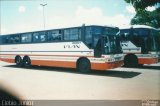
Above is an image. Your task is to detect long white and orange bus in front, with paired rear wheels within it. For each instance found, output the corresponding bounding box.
[0,25,124,73]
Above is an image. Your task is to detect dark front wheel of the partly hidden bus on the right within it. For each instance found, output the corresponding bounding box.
[124,54,138,68]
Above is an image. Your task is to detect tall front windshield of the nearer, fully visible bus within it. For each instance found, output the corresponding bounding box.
[104,28,122,54]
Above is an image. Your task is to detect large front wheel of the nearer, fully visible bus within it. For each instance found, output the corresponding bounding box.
[77,58,91,73]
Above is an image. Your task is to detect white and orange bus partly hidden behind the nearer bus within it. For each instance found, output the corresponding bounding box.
[120,25,160,67]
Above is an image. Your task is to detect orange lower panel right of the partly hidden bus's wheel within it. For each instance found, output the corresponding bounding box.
[138,58,158,64]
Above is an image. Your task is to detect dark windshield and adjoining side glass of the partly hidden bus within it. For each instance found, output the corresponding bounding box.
[130,28,158,53]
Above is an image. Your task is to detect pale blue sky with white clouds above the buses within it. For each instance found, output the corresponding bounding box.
[0,0,136,34]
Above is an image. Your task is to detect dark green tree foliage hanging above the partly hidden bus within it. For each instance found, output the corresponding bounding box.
[125,0,160,28]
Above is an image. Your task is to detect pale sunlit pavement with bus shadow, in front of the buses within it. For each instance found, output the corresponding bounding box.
[0,62,160,100]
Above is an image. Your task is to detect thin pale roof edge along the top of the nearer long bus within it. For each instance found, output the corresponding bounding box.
[1,24,118,36]
